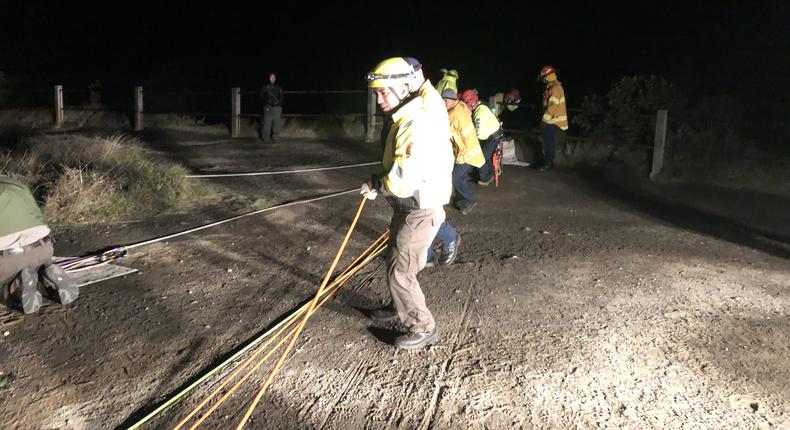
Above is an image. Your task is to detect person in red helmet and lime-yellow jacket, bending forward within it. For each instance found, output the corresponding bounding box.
[461,89,502,187]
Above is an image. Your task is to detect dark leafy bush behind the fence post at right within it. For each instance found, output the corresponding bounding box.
[575,76,687,145]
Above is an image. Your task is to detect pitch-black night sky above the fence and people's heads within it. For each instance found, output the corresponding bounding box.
[0,0,790,100]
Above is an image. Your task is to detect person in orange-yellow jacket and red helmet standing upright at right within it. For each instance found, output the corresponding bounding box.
[538,66,568,172]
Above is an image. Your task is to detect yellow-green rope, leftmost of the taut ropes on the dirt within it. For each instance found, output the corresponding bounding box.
[128,231,389,430]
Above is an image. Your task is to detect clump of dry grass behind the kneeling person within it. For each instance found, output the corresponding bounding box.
[0,134,210,226]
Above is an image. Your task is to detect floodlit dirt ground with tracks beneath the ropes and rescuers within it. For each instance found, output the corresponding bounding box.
[0,135,790,429]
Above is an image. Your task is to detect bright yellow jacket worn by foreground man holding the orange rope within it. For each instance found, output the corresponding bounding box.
[382,80,454,209]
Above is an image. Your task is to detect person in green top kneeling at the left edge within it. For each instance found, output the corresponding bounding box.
[0,176,79,314]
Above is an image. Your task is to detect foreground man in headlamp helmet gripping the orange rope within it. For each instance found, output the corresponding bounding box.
[361,57,453,349]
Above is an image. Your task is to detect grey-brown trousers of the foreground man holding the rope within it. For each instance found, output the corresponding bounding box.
[387,207,445,332]
